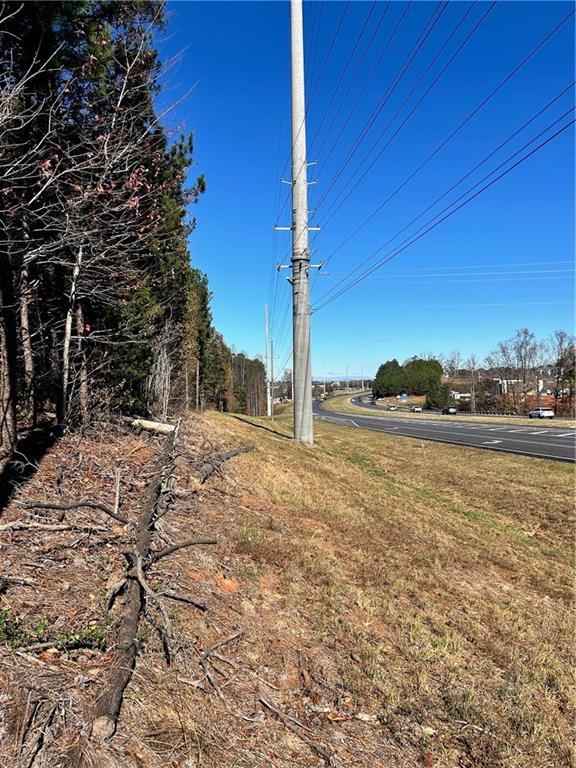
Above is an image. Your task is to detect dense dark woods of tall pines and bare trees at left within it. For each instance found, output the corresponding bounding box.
[0,2,264,458]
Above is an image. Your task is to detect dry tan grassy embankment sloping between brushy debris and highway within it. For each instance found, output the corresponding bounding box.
[202,414,574,768]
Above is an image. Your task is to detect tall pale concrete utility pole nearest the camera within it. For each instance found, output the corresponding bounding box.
[290,0,314,444]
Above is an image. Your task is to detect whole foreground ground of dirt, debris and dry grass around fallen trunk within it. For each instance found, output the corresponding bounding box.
[0,414,574,768]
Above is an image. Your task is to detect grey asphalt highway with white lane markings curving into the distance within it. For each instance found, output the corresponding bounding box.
[313,401,576,462]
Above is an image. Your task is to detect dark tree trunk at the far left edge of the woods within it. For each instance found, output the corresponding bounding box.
[0,268,17,461]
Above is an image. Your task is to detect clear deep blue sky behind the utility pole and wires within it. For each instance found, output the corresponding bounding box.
[158,1,574,376]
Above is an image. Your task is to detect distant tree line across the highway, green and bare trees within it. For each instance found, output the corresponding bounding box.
[373,328,576,415]
